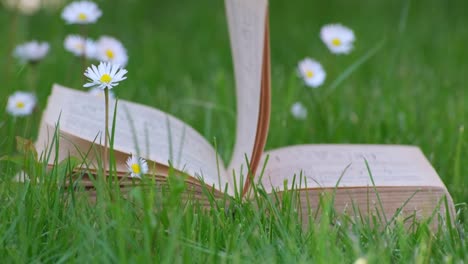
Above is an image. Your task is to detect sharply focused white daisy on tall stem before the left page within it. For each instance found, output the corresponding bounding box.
[83,62,127,89]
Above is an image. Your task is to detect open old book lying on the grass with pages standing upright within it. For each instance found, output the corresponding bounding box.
[36,0,453,223]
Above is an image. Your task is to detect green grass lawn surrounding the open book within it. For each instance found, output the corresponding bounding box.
[0,0,468,263]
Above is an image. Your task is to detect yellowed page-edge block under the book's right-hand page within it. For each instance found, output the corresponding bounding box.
[288,186,456,229]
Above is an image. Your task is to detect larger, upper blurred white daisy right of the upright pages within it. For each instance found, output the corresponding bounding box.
[320,24,355,54]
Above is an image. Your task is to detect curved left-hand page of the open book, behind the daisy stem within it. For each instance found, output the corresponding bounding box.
[37,85,228,189]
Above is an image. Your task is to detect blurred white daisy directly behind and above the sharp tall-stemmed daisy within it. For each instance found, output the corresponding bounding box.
[96,36,128,67]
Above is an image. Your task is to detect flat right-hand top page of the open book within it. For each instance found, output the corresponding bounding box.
[260,145,445,191]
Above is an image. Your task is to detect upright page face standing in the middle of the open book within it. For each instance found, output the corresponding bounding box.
[225,0,269,182]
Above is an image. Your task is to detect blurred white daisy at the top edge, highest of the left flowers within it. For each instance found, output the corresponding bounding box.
[62,1,102,24]
